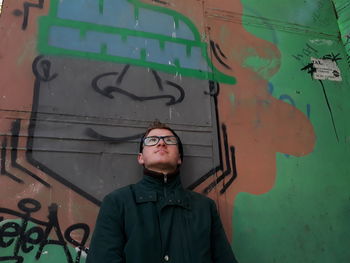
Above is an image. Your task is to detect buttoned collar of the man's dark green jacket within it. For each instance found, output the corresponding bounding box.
[133,168,191,209]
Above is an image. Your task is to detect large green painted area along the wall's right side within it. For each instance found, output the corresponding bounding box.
[233,1,350,263]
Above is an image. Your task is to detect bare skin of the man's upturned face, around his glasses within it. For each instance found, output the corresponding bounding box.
[137,129,181,173]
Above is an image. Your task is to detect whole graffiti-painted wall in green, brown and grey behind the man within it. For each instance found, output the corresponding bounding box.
[0,0,350,263]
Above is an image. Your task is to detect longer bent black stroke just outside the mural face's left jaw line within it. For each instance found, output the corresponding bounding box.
[11,119,51,188]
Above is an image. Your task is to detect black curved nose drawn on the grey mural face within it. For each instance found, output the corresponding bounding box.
[91,65,185,106]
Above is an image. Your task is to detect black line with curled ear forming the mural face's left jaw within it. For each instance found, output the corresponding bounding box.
[26,55,101,206]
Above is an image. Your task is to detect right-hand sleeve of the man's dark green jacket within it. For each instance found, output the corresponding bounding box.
[211,200,238,263]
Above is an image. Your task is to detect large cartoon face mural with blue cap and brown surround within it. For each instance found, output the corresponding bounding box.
[0,0,314,255]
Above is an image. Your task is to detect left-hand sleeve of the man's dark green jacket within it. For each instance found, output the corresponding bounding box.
[86,195,126,263]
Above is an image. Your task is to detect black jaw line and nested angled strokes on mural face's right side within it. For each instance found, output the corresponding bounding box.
[188,81,238,194]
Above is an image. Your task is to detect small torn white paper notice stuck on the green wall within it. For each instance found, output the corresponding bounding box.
[311,58,342,81]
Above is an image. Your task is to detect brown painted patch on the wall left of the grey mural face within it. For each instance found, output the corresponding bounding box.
[0,0,98,245]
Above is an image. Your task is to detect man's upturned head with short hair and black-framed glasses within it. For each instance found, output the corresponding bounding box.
[137,121,183,173]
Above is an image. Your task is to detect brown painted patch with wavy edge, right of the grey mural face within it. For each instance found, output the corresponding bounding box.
[196,0,315,241]
